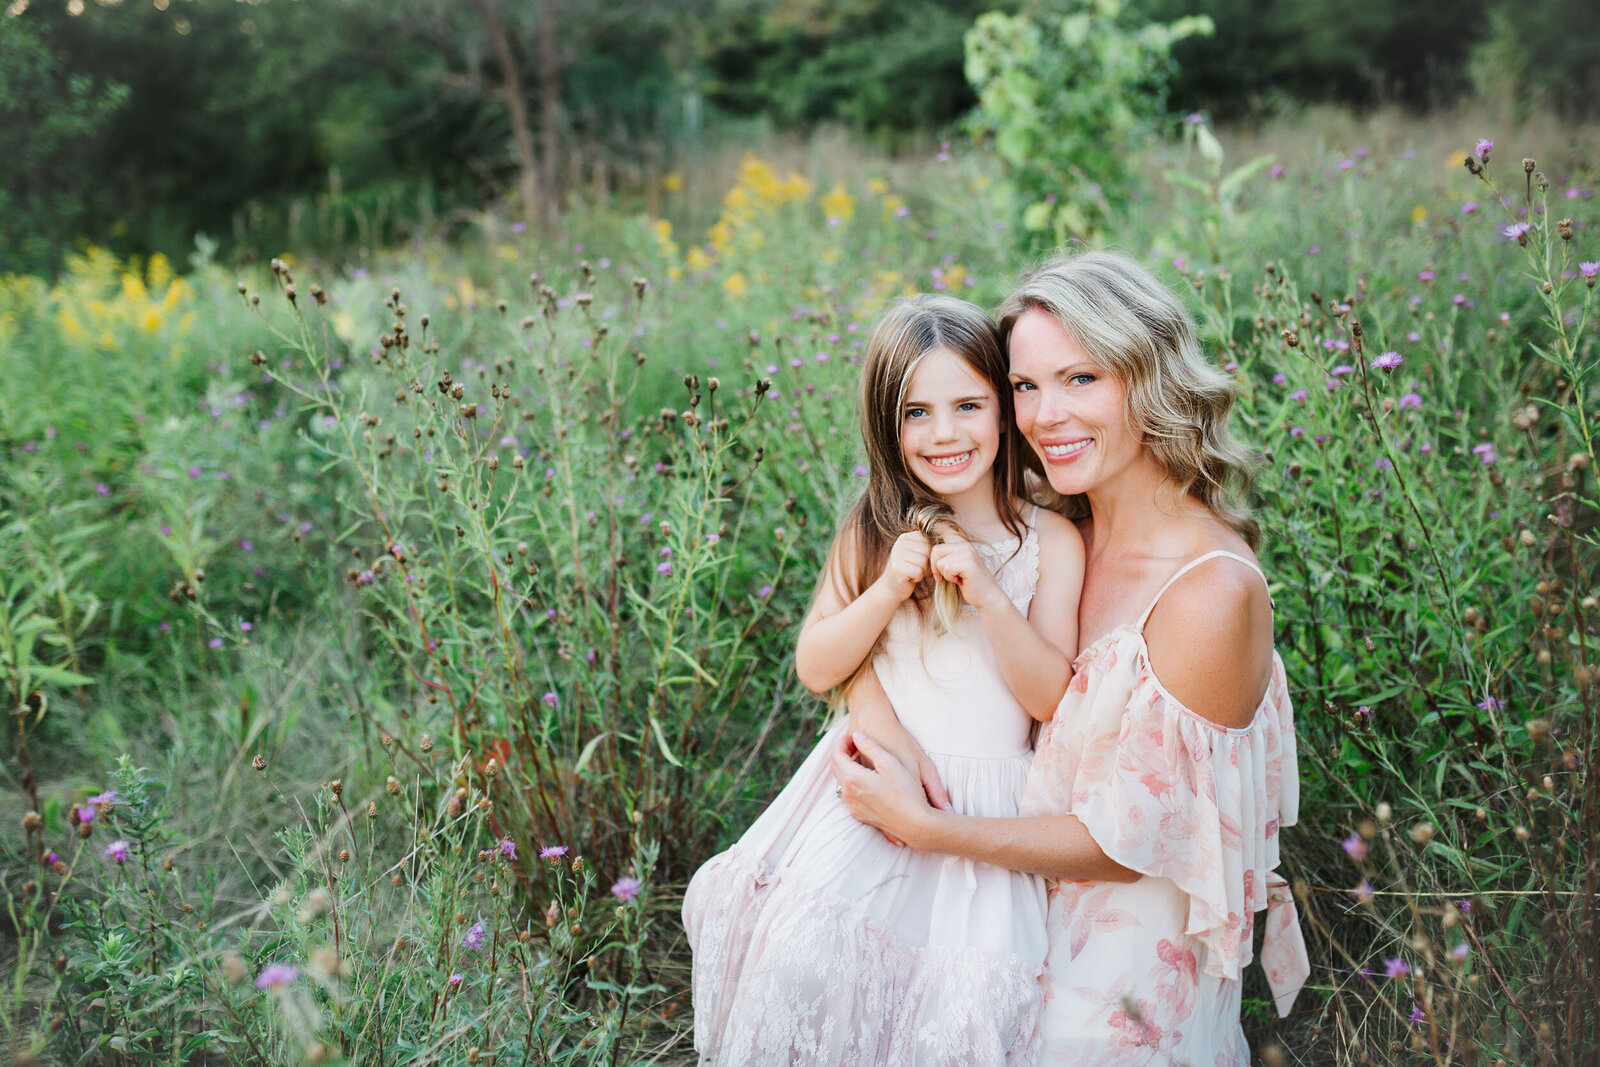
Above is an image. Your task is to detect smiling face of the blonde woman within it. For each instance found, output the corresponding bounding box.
[1008,309,1146,496]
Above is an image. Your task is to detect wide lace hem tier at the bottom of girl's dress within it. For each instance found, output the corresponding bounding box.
[683,848,1042,1067]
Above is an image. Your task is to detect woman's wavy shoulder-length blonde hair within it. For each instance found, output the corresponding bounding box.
[1000,251,1261,549]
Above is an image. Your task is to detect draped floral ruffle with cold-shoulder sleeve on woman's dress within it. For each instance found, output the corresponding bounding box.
[1026,643,1309,1009]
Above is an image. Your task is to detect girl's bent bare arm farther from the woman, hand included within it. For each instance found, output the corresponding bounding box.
[795,531,930,693]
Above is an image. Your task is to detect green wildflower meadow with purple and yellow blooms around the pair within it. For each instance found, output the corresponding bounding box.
[0,112,1600,1064]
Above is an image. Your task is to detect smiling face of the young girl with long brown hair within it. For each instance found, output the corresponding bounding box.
[901,349,1000,499]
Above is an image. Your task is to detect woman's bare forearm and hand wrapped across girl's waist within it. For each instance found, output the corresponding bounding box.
[832,733,1139,881]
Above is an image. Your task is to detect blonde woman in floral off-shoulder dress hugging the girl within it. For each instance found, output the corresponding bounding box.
[834,253,1309,1067]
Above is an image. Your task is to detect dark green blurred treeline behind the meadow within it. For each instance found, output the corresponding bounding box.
[0,0,1600,272]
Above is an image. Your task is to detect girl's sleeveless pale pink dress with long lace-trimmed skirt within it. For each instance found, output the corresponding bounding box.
[683,530,1045,1067]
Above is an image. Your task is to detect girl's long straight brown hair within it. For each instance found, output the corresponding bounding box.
[822,294,1022,630]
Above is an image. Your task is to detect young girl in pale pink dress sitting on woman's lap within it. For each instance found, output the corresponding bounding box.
[683,296,1083,1067]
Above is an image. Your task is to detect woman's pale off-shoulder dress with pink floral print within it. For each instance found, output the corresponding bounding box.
[1022,552,1309,1067]
